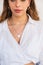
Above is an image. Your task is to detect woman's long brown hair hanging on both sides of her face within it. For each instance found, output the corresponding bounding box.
[0,0,39,22]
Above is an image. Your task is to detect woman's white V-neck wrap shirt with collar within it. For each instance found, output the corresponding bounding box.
[0,18,43,65]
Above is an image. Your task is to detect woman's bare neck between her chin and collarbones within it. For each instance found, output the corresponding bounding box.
[10,14,28,25]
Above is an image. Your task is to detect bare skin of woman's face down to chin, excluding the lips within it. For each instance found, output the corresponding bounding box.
[9,0,30,16]
